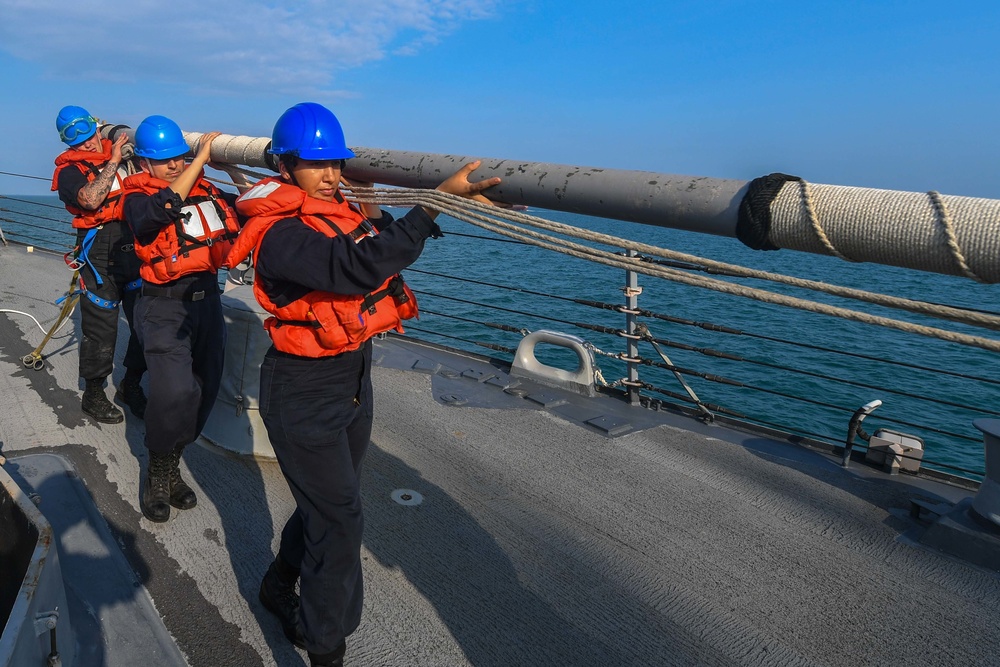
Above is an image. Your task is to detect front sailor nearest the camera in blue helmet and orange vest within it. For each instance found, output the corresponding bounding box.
[226,102,500,667]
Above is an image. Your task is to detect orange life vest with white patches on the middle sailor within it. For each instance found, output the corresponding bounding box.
[125,170,240,284]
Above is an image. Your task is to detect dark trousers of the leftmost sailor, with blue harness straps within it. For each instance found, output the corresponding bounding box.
[77,221,146,380]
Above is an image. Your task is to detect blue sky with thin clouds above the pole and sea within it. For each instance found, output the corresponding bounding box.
[0,0,1000,198]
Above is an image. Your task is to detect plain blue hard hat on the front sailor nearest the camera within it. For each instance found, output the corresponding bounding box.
[267,102,354,160]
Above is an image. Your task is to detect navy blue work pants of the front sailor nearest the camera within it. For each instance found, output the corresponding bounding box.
[260,341,372,654]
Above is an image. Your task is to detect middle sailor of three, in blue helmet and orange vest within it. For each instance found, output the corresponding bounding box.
[124,116,248,523]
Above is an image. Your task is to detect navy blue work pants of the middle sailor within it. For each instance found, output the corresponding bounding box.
[135,292,226,454]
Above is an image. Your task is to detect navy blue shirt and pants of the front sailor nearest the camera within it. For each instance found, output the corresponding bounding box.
[254,208,440,655]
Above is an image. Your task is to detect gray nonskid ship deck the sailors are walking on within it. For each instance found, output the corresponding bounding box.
[0,241,1000,666]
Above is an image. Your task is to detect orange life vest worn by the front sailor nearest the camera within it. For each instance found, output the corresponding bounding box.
[226,178,418,358]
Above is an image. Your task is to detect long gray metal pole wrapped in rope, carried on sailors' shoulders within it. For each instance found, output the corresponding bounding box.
[105,126,1000,283]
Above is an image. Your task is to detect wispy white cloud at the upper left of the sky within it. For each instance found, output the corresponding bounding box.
[0,0,497,93]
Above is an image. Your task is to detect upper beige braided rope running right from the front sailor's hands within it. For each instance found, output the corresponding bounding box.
[350,188,1000,330]
